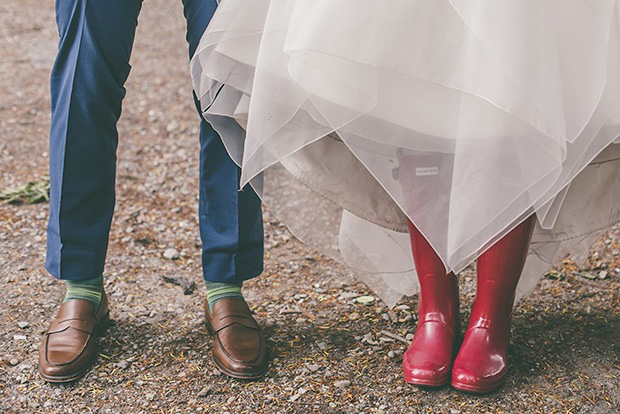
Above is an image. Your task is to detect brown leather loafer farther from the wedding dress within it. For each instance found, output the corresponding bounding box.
[39,292,110,382]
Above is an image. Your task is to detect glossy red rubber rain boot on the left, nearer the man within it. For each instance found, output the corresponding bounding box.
[403,222,460,387]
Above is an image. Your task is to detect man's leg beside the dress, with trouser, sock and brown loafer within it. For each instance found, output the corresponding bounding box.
[183,0,267,379]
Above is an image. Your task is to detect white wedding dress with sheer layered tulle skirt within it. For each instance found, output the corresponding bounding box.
[191,0,620,305]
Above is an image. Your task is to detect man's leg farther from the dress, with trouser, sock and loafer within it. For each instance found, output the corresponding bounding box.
[39,0,142,382]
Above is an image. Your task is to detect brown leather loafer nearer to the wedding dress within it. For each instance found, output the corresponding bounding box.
[205,298,268,379]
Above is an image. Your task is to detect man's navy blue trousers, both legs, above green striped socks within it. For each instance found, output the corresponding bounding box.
[46,0,263,283]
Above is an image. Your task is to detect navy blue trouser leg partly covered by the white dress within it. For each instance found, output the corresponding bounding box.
[183,0,263,283]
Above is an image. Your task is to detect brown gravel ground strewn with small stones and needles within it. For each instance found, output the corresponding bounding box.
[0,0,620,413]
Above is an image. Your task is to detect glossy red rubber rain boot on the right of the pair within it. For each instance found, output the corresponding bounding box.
[452,216,535,393]
